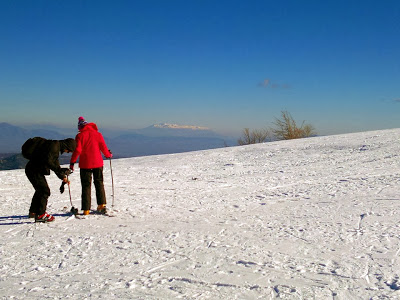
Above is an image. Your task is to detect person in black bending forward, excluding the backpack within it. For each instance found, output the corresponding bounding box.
[25,138,76,222]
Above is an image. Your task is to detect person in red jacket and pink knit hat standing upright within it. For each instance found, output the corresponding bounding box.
[70,117,112,215]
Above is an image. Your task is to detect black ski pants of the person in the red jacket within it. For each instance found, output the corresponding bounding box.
[80,167,106,210]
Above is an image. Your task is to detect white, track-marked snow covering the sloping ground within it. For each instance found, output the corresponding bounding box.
[0,129,400,300]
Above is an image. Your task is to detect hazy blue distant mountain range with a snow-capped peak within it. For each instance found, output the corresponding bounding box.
[0,123,236,170]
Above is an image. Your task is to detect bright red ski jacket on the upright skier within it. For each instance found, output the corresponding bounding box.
[71,123,112,169]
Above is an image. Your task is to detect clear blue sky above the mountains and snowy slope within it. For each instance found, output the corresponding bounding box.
[0,0,400,134]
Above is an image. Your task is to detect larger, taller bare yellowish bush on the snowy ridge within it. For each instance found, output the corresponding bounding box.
[272,111,316,140]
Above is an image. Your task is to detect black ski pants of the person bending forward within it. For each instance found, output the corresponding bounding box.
[25,162,50,216]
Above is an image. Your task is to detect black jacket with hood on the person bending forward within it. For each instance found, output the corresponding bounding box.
[30,139,76,179]
